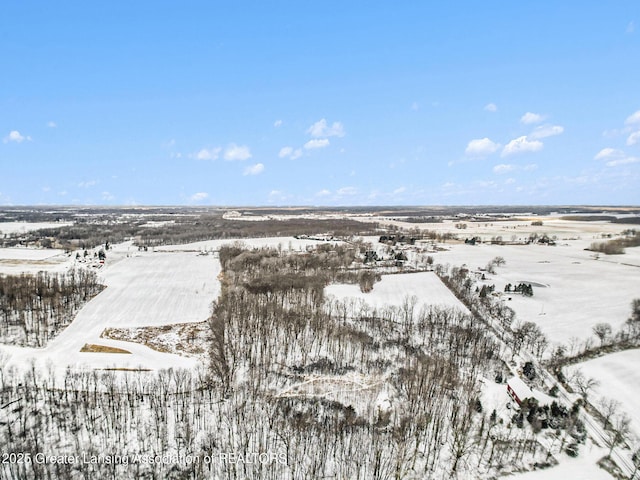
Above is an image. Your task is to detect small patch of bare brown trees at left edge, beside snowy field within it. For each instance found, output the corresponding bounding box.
[0,269,104,347]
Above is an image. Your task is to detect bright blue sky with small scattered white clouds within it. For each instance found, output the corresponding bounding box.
[0,0,640,205]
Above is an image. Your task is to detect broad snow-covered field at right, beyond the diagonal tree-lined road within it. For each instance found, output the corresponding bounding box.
[433,242,640,344]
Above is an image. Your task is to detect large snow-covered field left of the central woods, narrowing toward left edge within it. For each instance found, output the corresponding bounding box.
[0,252,220,371]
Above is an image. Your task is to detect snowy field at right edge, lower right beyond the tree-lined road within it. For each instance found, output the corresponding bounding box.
[567,349,640,435]
